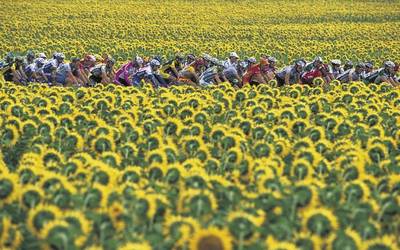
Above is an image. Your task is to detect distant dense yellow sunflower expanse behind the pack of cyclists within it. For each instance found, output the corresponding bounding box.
[0,0,400,66]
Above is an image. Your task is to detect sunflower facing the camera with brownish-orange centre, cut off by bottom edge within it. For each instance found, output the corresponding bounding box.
[189,227,233,250]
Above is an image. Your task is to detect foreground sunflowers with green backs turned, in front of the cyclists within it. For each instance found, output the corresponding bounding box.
[0,79,400,250]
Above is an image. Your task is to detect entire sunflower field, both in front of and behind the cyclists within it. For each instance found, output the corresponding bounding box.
[0,0,400,250]
